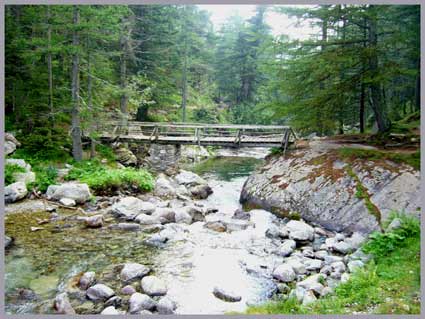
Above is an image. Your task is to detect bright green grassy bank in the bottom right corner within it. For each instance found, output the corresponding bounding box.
[247,217,420,314]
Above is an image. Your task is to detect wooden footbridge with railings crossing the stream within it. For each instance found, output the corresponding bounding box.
[94,121,296,150]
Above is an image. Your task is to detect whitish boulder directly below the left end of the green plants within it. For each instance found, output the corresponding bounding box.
[46,183,91,204]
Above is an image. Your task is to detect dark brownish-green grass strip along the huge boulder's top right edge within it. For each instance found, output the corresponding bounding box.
[338,147,421,170]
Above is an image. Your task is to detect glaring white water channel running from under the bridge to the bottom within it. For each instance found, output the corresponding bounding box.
[154,151,282,314]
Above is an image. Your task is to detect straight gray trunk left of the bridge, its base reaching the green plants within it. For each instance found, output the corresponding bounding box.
[71,5,83,161]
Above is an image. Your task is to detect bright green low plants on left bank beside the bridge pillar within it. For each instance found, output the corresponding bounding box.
[65,160,154,192]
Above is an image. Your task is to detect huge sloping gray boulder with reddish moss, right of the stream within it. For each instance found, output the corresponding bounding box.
[240,140,421,234]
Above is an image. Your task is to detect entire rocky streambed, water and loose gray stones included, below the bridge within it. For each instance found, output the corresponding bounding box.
[5,148,378,314]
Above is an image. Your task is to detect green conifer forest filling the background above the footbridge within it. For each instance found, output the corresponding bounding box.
[5,4,420,159]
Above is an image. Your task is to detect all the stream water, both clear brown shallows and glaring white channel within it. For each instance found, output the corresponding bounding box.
[5,151,281,314]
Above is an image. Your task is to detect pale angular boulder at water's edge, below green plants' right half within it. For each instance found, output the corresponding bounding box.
[111,196,155,220]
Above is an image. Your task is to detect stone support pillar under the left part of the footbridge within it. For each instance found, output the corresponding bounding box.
[146,144,181,173]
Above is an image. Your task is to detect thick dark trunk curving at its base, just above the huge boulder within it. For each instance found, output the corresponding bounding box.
[368,5,390,133]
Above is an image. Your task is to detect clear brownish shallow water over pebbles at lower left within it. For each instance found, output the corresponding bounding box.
[5,210,154,313]
